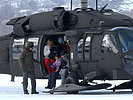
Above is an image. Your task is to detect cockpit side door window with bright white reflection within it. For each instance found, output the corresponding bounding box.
[102,34,118,54]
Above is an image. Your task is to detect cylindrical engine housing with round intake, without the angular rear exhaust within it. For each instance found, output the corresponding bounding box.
[29,9,77,31]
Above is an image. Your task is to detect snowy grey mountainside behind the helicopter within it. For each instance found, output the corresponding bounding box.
[0,0,133,35]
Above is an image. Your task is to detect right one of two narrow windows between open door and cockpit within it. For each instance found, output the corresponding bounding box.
[84,36,91,58]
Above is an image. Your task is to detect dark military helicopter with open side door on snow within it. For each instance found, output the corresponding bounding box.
[0,0,133,93]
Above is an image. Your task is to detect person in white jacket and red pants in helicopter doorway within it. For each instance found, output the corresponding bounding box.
[44,39,55,74]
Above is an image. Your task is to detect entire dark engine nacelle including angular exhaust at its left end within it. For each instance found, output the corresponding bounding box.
[7,9,77,36]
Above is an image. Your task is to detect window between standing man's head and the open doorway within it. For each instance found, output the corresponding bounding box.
[28,38,39,59]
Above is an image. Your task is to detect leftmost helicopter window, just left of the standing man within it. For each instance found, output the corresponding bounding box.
[12,38,24,59]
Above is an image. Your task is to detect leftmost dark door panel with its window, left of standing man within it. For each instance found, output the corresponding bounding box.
[10,36,25,76]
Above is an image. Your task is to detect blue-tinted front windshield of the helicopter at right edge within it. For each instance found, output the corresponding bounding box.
[118,31,133,52]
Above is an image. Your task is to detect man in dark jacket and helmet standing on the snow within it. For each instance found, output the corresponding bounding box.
[19,42,39,94]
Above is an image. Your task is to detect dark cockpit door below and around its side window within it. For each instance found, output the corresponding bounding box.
[98,32,122,79]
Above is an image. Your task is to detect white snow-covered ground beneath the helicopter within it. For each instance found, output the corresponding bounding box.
[0,74,133,100]
